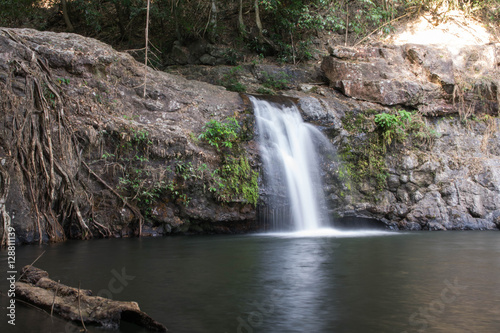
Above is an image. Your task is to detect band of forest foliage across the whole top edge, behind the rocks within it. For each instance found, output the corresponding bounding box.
[0,0,500,68]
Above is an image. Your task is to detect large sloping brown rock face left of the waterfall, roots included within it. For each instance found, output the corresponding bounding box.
[0,29,258,243]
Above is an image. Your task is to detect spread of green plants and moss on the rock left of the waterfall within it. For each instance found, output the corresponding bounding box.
[101,113,258,217]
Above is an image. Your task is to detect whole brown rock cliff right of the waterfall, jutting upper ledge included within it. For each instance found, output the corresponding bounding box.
[314,44,500,230]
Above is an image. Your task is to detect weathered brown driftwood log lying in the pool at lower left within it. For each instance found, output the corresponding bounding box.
[16,266,167,332]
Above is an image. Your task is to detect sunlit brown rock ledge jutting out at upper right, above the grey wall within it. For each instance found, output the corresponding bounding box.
[321,44,500,115]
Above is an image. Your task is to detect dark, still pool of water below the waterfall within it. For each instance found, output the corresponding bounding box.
[0,232,500,333]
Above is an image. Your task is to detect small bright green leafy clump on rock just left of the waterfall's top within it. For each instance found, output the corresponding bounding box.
[198,117,240,150]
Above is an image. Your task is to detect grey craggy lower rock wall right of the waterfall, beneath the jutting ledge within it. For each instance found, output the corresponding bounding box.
[282,86,500,230]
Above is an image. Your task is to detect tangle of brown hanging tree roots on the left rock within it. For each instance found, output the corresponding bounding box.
[0,30,110,245]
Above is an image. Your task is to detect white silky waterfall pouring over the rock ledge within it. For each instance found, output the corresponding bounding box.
[254,96,330,231]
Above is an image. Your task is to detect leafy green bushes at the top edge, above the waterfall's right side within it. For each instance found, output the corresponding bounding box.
[251,0,400,63]
